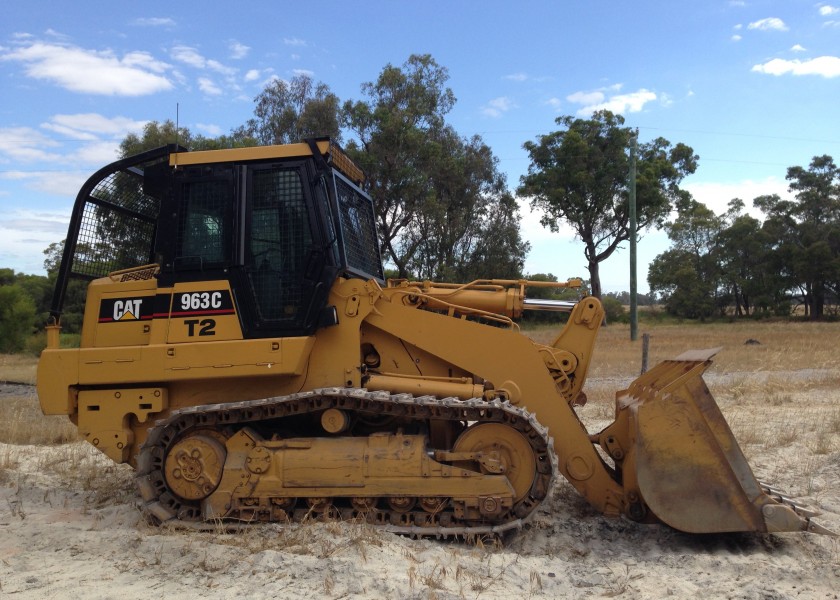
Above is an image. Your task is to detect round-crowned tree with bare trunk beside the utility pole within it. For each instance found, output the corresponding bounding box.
[517,110,698,297]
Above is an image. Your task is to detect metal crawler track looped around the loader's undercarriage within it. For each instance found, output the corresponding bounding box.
[136,388,557,537]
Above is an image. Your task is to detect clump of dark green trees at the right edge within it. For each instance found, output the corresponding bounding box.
[648,156,840,319]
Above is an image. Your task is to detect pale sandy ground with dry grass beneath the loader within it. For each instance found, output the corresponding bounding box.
[0,388,840,600]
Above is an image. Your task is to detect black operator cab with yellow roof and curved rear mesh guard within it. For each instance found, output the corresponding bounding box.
[52,139,383,339]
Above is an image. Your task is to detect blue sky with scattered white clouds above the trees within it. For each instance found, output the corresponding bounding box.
[0,0,840,291]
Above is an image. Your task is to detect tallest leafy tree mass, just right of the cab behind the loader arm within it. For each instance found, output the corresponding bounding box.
[344,55,527,280]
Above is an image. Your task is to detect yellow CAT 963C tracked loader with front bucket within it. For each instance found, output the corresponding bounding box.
[38,139,832,536]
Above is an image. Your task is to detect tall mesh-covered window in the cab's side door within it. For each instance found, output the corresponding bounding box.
[251,168,312,325]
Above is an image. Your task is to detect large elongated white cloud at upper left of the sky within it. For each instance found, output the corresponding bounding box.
[0,42,173,96]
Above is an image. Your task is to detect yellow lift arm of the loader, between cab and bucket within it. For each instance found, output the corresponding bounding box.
[366,290,627,516]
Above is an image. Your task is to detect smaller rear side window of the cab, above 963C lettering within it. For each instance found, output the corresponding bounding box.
[176,180,233,268]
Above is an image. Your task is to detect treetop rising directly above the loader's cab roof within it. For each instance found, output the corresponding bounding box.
[233,75,341,145]
